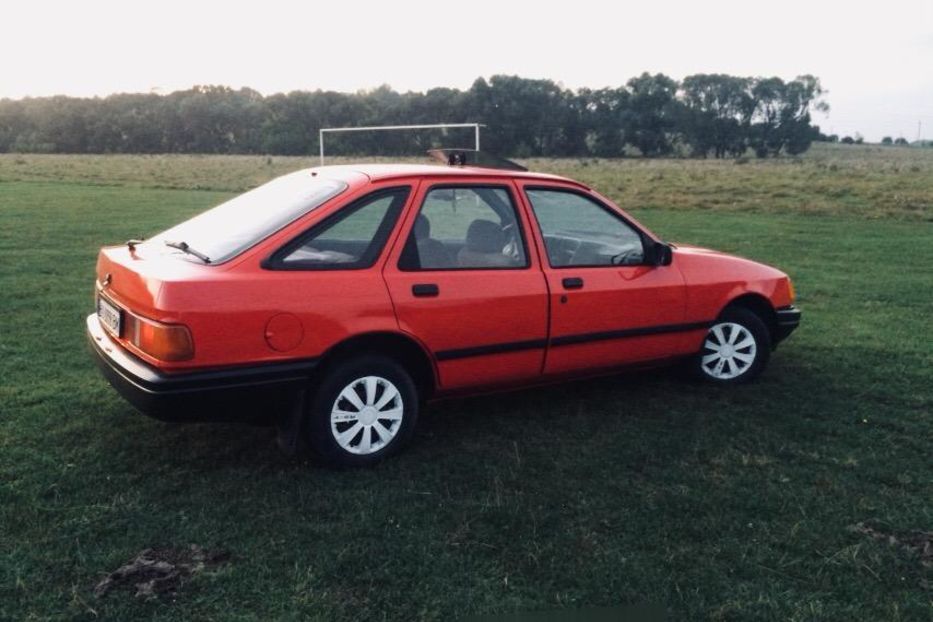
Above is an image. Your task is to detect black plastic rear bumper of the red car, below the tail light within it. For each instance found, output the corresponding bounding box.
[86,314,317,421]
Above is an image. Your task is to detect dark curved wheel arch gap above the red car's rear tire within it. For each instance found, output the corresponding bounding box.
[321,331,438,398]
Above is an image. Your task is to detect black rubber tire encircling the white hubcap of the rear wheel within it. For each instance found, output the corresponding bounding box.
[302,355,419,467]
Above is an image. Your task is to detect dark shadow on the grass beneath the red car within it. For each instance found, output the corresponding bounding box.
[118,356,825,478]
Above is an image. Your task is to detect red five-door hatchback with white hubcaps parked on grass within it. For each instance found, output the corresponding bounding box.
[87,152,800,465]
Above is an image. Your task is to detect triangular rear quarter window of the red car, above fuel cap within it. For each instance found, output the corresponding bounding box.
[273,187,410,270]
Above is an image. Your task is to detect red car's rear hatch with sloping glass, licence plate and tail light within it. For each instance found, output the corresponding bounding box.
[91,169,359,366]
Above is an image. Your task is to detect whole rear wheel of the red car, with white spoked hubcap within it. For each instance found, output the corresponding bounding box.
[305,355,418,466]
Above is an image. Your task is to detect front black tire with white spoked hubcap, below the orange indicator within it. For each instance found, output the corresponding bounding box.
[690,307,771,384]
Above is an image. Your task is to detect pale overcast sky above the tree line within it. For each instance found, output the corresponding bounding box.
[0,0,933,141]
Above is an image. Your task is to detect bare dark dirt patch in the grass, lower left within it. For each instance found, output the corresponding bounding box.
[94,544,230,598]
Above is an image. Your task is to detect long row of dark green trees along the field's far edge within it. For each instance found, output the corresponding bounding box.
[0,73,828,158]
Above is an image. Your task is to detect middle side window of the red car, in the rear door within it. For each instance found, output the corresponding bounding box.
[399,186,528,270]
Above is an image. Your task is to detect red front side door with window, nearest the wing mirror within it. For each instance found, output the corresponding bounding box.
[520,183,690,375]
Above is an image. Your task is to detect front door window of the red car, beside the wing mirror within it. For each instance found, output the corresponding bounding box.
[526,189,645,268]
